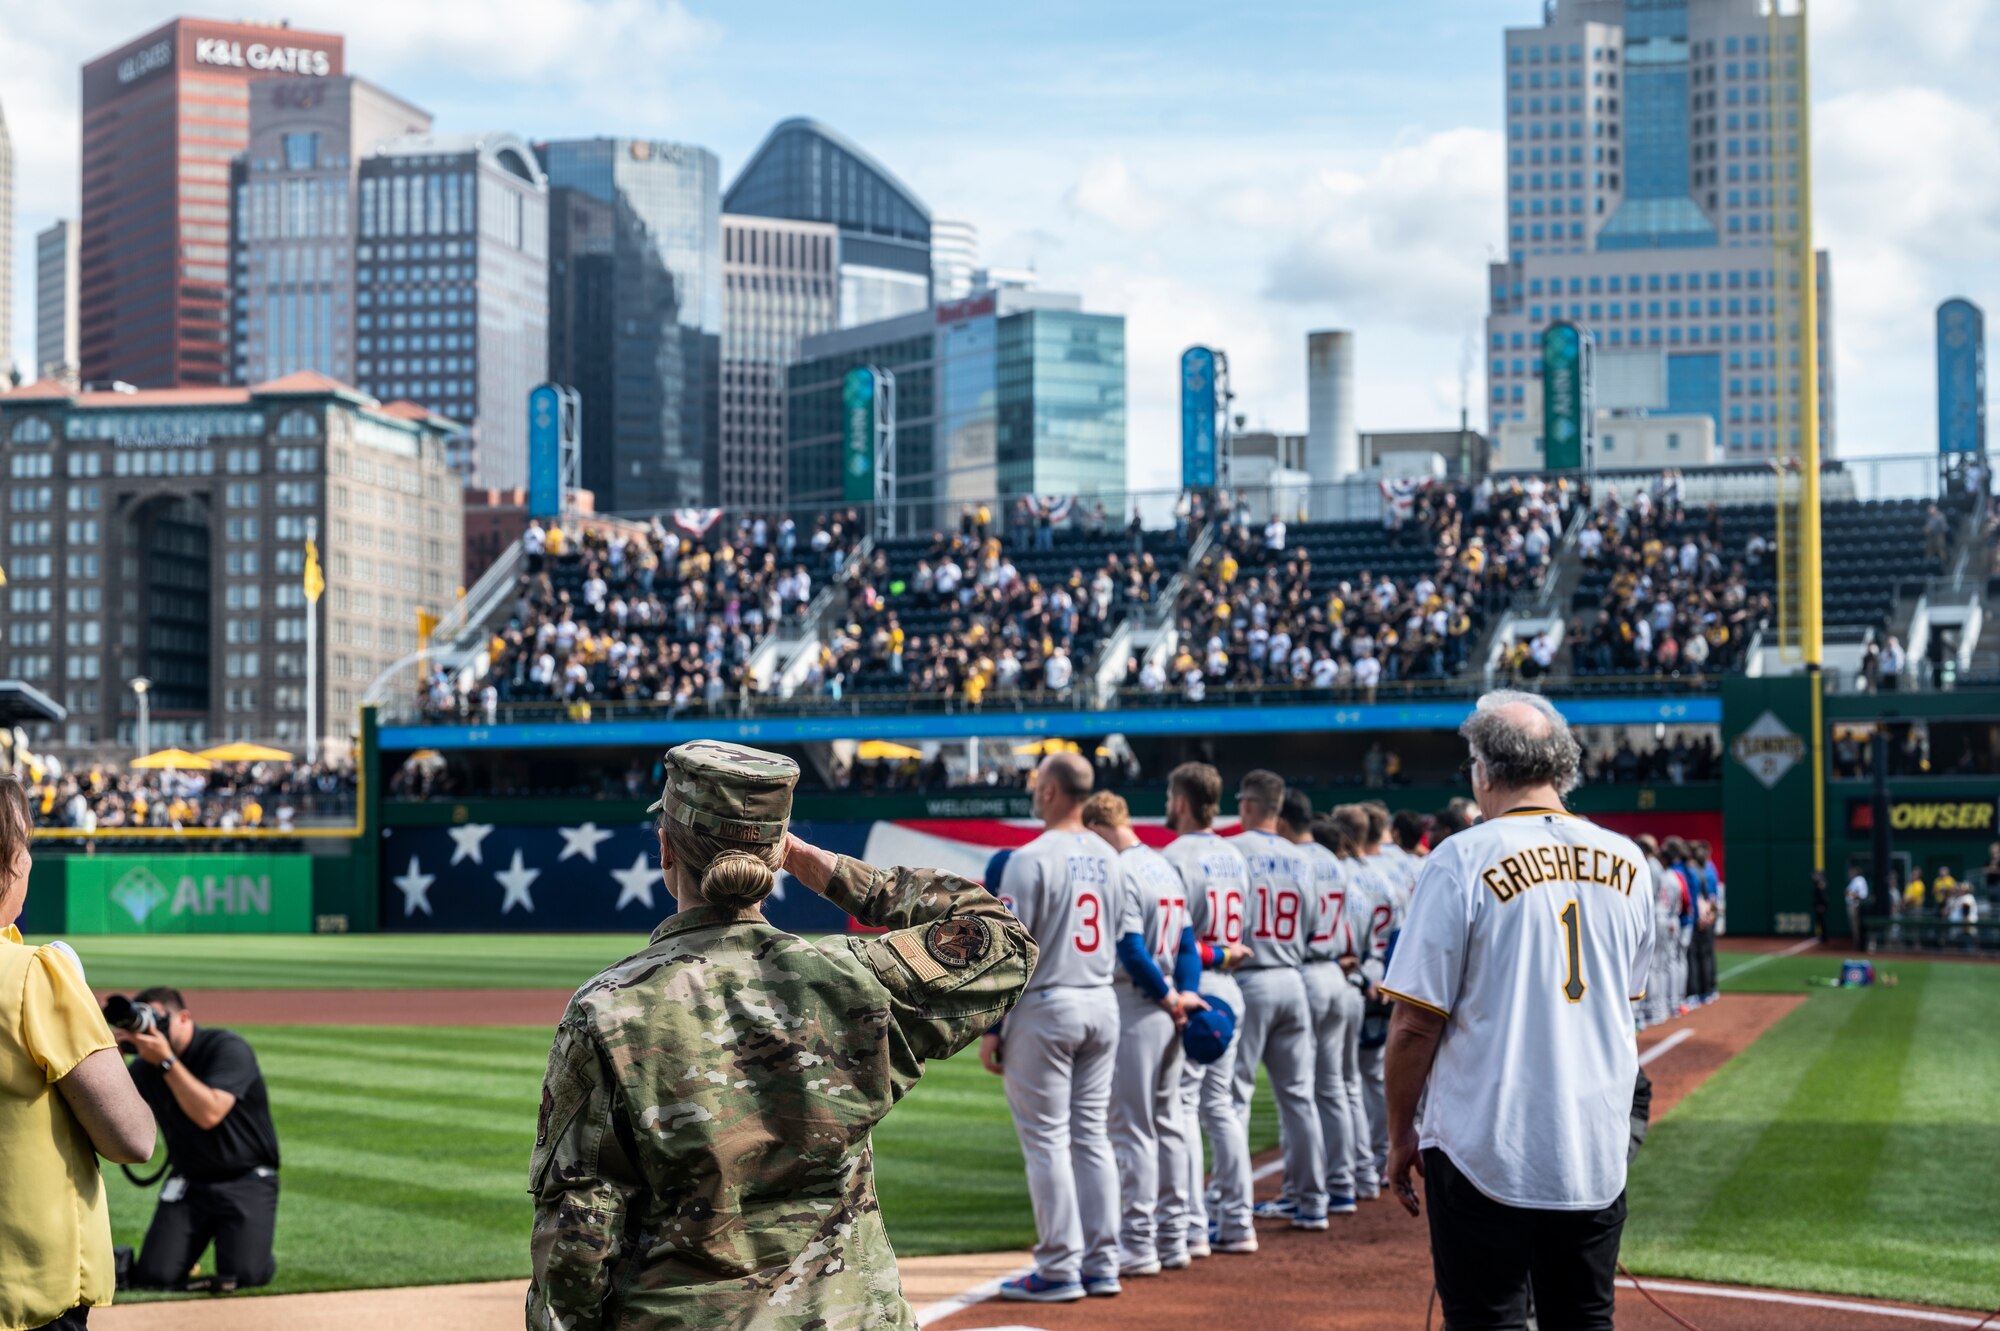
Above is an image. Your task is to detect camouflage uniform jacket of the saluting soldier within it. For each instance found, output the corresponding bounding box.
[528,859,1036,1331]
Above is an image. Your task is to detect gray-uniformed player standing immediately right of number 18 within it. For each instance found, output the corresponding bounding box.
[1278,789,1362,1215]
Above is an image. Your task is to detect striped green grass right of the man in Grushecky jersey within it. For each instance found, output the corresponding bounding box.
[1624,957,2000,1307]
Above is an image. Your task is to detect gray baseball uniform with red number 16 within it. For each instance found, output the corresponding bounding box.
[1162,831,1250,1245]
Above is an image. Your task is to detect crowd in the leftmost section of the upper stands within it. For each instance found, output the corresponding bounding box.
[424,510,864,715]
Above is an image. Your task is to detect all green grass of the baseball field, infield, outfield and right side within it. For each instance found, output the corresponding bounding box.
[47,935,2000,1309]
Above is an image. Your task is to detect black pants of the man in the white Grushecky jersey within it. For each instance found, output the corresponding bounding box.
[1424,1147,1624,1331]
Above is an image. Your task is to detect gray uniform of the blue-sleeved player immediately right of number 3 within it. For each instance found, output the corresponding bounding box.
[1110,845,1188,1267]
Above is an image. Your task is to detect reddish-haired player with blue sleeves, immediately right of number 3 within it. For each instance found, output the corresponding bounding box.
[1084,789,1208,1275]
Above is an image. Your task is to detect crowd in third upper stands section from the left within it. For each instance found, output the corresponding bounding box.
[1160,478,1576,701]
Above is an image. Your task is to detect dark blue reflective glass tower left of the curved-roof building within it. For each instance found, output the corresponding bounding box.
[536,138,722,514]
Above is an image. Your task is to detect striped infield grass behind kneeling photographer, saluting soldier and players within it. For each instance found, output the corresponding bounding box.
[106,1025,1278,1299]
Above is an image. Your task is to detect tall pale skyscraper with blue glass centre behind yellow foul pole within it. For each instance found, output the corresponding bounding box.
[1486,0,1834,462]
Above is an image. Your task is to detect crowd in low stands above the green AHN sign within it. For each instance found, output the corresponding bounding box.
[28,761,354,831]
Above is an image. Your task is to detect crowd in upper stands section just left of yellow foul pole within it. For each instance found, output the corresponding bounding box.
[1560,470,1772,679]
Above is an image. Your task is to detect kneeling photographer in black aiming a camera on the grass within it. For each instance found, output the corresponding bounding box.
[104,987,278,1289]
